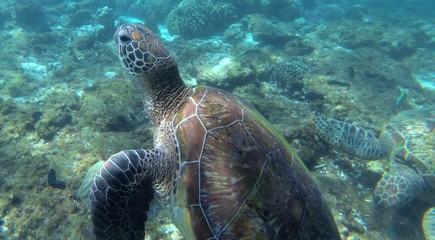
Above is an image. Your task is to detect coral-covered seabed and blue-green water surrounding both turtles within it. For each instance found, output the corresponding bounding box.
[0,0,435,239]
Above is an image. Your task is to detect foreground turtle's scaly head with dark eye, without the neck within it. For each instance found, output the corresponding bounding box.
[115,23,175,76]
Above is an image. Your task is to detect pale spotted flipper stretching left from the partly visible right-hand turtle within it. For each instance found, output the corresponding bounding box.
[313,112,392,159]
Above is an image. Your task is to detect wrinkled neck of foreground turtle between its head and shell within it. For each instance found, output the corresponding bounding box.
[132,62,191,127]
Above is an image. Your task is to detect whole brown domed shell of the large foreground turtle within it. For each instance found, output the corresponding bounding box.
[171,87,339,239]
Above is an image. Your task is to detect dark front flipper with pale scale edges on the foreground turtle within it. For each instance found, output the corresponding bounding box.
[89,150,156,239]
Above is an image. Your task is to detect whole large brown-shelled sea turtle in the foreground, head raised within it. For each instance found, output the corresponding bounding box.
[90,24,340,240]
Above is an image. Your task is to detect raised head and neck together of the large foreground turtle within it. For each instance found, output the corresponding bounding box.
[115,23,188,124]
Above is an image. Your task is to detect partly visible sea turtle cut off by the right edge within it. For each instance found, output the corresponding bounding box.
[314,105,435,208]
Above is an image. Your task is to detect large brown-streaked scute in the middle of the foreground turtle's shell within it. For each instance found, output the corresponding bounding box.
[200,122,266,236]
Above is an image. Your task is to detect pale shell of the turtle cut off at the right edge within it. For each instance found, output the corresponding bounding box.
[386,106,435,188]
